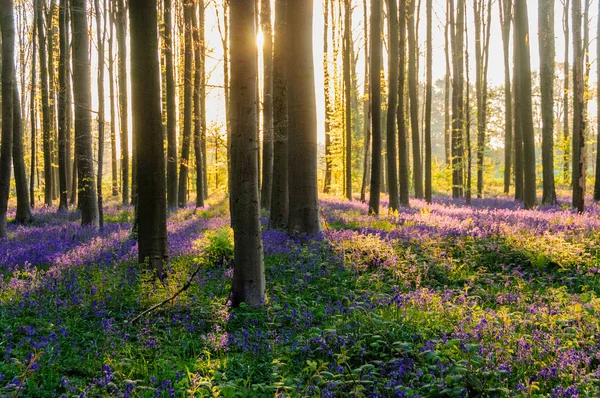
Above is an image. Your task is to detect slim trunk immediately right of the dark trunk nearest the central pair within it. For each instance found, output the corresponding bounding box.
[386,0,400,211]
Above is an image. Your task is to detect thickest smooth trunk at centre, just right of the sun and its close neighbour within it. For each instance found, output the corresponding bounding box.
[287,1,321,235]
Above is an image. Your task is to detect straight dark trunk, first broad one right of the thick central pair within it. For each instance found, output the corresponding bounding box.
[369,0,382,215]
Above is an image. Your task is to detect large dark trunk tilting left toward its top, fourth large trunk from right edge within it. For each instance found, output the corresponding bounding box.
[515,0,536,209]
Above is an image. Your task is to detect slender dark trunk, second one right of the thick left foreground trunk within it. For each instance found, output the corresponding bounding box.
[177,0,194,207]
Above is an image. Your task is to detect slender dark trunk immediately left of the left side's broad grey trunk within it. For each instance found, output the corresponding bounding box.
[58,0,71,212]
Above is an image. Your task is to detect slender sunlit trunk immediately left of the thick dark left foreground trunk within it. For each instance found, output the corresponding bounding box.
[113,0,129,205]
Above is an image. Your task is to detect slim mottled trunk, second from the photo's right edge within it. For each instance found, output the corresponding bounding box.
[572,0,586,213]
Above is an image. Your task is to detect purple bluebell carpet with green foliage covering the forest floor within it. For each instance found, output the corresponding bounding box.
[0,194,600,397]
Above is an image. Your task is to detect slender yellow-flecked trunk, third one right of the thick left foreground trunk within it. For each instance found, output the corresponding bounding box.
[192,0,206,207]
